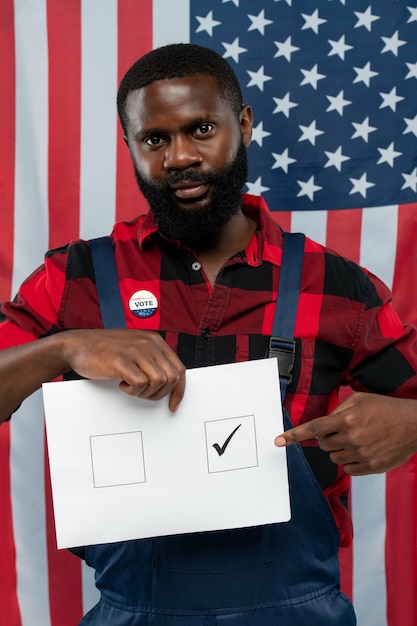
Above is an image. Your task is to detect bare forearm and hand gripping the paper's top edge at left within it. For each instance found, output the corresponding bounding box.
[0,330,185,422]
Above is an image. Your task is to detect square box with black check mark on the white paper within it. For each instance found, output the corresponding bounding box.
[204,415,258,474]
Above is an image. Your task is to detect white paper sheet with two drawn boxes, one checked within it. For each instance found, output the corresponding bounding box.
[43,359,290,548]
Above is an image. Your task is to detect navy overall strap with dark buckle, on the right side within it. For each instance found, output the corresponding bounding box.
[268,233,305,402]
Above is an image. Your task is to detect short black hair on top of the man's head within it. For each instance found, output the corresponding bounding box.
[117,43,243,132]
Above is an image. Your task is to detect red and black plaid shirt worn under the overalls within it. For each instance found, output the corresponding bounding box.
[0,195,417,540]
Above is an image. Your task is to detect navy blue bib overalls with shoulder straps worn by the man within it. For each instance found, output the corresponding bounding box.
[80,234,356,626]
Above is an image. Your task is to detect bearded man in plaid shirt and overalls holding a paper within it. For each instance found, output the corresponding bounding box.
[0,44,417,626]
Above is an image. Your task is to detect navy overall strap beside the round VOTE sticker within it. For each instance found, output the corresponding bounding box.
[90,237,126,328]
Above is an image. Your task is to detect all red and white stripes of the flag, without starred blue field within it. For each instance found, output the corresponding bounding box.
[0,0,417,626]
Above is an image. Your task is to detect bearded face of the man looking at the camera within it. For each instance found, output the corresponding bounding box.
[122,75,252,246]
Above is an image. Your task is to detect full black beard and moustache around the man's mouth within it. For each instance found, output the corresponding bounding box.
[135,142,248,248]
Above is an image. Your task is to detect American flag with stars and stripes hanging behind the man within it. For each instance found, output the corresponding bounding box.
[0,0,417,626]
